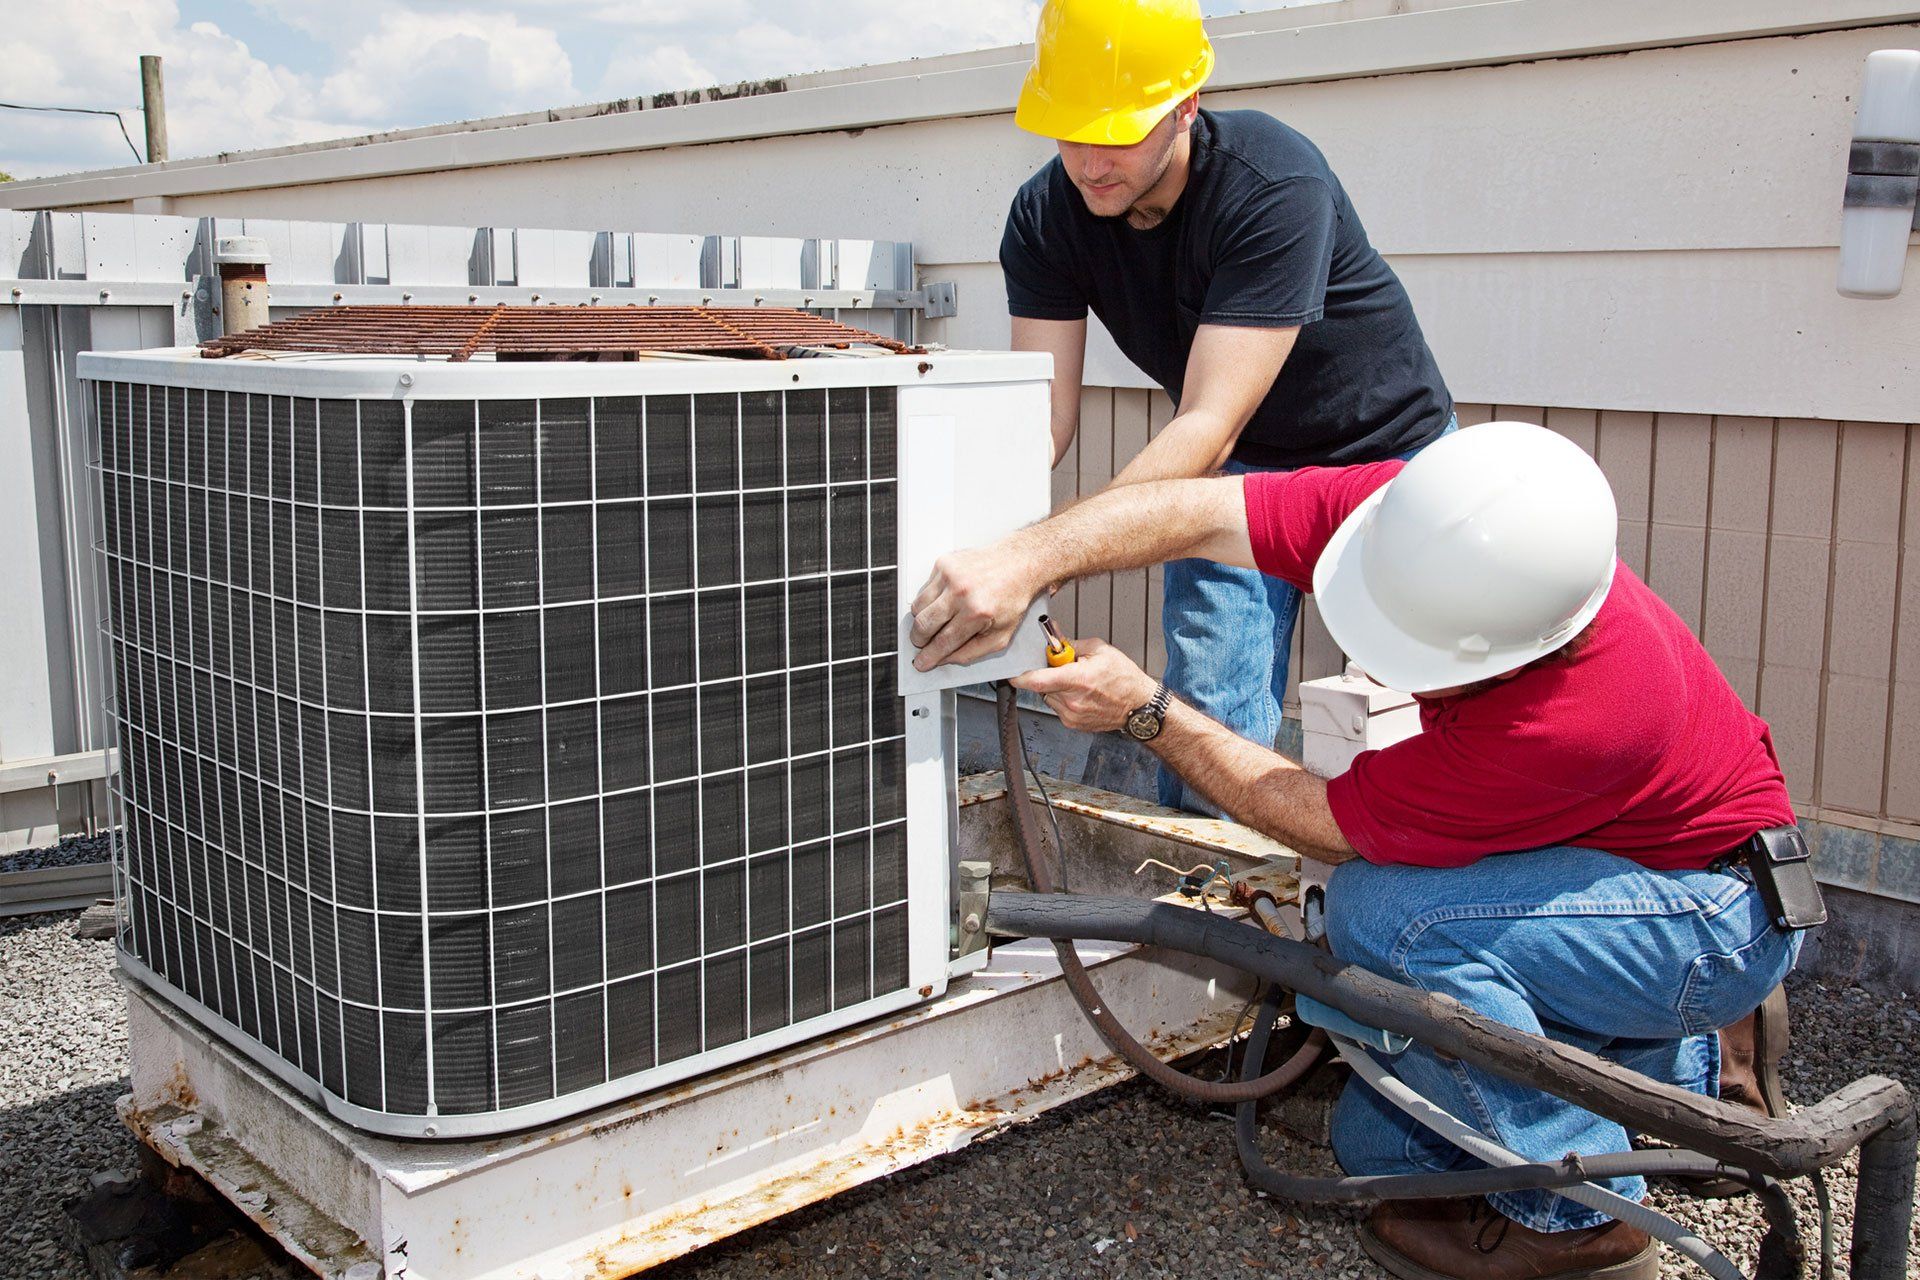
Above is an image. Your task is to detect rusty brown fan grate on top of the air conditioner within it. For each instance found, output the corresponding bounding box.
[200,305,922,361]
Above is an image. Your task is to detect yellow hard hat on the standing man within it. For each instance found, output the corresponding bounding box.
[1014,0,1213,146]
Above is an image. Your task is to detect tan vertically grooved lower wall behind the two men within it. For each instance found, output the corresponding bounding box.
[1054,401,1920,837]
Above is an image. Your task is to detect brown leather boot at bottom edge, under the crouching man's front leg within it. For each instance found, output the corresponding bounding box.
[1359,1196,1661,1280]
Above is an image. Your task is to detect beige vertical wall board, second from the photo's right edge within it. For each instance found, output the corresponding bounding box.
[1820,422,1907,814]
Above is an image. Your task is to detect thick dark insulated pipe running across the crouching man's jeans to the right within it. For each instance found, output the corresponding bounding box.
[987,894,1916,1280]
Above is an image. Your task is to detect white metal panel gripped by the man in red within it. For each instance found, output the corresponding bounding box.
[899,380,1052,693]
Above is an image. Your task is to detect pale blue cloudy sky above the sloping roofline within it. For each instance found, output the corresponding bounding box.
[0,0,1311,178]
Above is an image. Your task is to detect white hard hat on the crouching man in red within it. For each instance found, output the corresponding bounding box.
[1313,422,1619,693]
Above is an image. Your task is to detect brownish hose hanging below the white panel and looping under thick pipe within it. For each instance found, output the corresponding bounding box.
[995,683,1327,1105]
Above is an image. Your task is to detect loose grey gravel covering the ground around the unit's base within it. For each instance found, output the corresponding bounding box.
[0,912,1920,1280]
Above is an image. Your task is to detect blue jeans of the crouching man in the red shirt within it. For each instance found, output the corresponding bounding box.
[1327,846,1803,1232]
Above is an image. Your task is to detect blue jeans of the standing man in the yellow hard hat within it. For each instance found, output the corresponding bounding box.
[1160,418,1459,818]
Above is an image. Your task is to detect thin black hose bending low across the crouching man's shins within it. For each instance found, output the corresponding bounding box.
[1233,988,1807,1280]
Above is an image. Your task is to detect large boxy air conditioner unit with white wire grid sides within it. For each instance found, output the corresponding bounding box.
[81,339,1050,1138]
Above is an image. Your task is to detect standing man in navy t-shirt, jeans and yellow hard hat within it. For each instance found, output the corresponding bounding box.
[1000,0,1453,812]
